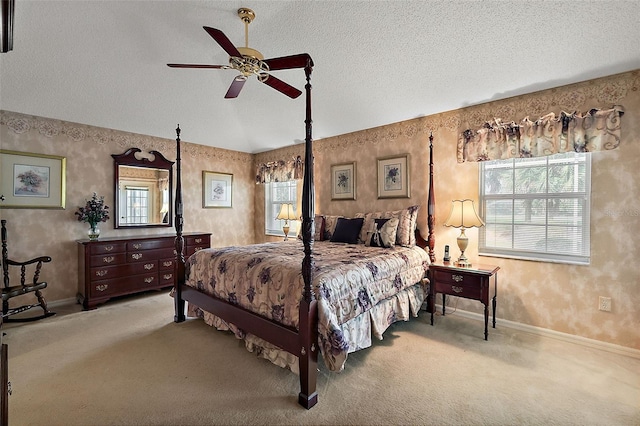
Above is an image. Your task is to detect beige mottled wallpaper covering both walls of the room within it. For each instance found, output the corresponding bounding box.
[0,71,640,349]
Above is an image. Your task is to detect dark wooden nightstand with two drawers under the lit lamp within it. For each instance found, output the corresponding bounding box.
[429,264,500,340]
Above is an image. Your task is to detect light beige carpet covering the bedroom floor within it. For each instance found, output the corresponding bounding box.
[4,292,640,425]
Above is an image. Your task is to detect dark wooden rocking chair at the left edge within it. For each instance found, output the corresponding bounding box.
[0,220,55,322]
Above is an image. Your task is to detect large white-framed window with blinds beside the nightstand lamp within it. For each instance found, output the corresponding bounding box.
[479,152,591,265]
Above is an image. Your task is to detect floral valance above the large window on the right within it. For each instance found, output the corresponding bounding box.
[458,106,624,163]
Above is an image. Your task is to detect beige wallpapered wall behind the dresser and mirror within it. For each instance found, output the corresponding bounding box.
[0,115,255,303]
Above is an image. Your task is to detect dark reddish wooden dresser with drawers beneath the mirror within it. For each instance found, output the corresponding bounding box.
[77,233,211,309]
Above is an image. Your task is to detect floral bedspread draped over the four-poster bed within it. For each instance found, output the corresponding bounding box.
[186,240,429,371]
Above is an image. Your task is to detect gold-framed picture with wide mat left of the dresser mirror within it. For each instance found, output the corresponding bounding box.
[0,150,67,209]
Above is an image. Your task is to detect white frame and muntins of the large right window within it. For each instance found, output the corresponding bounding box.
[478,153,591,265]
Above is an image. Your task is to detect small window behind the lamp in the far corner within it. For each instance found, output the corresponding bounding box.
[264,180,300,237]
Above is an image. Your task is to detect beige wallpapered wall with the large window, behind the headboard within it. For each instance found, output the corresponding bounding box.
[255,71,640,349]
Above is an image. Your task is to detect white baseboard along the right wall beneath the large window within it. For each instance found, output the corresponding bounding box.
[436,305,640,359]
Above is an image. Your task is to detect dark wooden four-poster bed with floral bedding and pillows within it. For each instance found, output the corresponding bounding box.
[173,55,435,409]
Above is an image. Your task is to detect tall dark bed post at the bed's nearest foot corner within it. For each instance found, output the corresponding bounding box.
[298,57,318,409]
